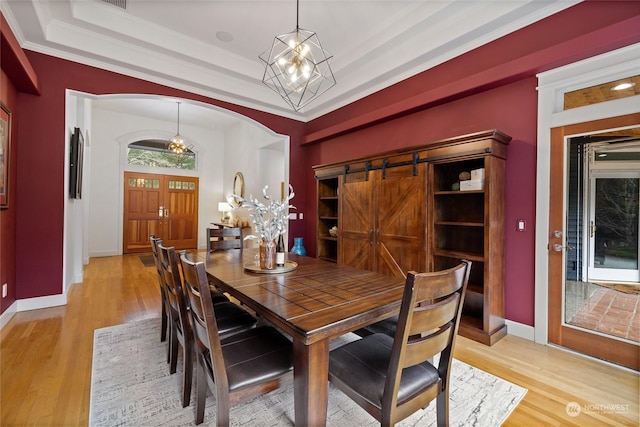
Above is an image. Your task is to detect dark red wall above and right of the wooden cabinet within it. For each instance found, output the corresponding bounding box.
[305,1,640,326]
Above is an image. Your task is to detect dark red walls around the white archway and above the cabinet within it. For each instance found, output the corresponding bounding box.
[2,1,640,325]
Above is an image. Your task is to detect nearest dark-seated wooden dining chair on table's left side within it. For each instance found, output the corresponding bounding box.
[180,255,293,426]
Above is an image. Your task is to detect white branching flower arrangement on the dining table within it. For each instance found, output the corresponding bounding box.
[229,185,296,242]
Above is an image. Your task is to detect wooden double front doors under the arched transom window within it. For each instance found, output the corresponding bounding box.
[122,172,198,254]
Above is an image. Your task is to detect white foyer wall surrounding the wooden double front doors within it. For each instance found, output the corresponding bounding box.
[83,97,288,257]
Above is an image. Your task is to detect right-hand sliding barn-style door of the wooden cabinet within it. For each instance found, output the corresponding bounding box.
[375,163,427,277]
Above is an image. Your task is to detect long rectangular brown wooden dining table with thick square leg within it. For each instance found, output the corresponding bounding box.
[195,249,405,426]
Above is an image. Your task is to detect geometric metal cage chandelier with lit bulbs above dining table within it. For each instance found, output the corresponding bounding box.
[259,0,336,111]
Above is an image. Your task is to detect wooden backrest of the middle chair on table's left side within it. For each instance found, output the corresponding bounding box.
[158,244,192,340]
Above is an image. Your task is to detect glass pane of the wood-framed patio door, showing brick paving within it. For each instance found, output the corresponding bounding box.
[562,137,640,342]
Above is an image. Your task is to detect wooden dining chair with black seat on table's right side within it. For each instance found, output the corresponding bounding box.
[329,261,471,426]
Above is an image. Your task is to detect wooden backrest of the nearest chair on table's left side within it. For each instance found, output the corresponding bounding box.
[180,254,229,390]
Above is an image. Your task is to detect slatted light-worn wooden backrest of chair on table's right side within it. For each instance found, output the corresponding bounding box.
[382,260,471,419]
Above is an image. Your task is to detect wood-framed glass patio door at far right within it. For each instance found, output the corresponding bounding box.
[548,114,640,370]
